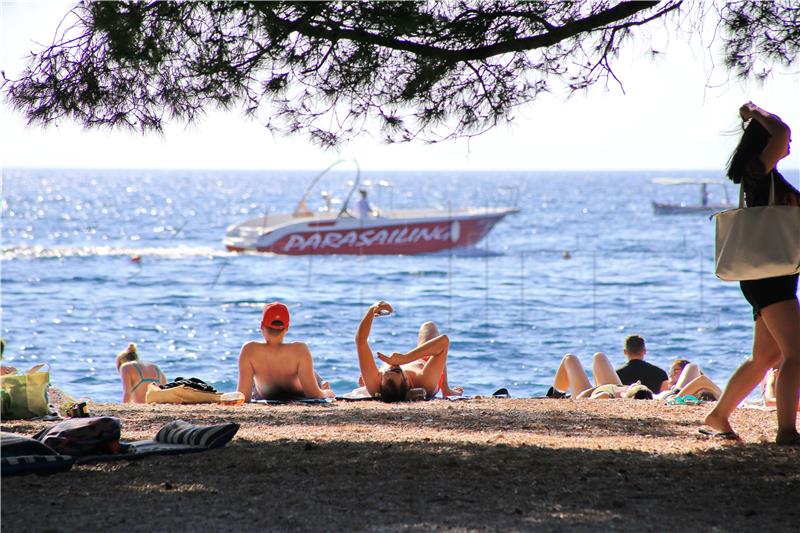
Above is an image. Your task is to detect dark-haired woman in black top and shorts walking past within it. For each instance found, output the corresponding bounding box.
[701,102,800,445]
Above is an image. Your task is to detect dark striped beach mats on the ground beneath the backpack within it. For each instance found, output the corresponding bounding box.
[0,420,239,476]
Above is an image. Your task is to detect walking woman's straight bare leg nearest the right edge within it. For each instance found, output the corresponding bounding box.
[761,299,800,444]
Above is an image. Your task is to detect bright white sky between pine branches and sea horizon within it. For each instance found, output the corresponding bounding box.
[0,0,800,172]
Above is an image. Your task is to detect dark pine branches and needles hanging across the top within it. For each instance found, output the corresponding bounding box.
[4,0,800,146]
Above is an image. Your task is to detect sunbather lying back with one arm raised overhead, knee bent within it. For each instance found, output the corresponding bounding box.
[356,301,461,402]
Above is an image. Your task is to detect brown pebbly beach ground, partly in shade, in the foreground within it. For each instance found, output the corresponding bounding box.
[2,399,800,532]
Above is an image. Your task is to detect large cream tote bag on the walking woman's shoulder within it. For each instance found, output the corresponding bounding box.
[713,176,800,281]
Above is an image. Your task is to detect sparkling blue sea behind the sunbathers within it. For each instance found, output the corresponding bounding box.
[2,169,798,401]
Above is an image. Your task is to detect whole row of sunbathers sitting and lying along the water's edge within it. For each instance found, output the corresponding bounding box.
[106,301,792,405]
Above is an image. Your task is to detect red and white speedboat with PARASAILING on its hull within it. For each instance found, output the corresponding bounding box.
[223,162,519,255]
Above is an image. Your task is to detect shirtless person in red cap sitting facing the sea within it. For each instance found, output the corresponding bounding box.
[237,302,335,402]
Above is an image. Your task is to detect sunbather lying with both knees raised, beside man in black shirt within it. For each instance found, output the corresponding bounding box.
[547,352,653,400]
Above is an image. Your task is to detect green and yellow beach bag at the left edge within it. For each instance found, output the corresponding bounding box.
[0,365,50,420]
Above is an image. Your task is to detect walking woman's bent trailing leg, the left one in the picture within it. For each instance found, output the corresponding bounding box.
[705,311,781,431]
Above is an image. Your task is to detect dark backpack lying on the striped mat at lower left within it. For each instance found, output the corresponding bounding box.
[33,416,122,456]
